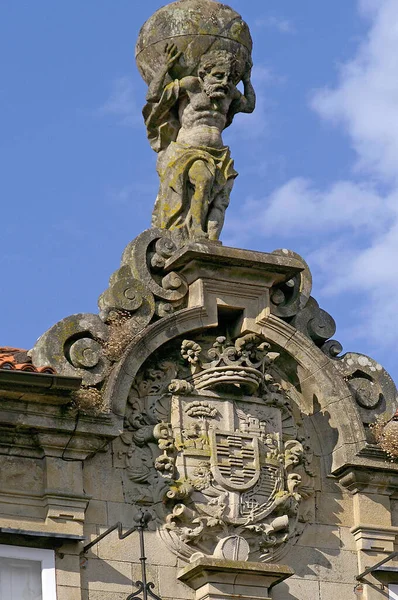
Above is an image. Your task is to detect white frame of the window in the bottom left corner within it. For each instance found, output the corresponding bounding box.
[0,544,57,600]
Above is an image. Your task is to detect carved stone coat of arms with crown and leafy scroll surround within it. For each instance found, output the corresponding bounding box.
[119,334,312,561]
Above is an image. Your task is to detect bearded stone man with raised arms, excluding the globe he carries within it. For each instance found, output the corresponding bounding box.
[143,44,256,240]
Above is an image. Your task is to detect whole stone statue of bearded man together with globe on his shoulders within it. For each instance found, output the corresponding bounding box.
[137,0,256,241]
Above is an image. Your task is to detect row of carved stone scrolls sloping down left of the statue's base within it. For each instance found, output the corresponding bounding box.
[31,229,188,387]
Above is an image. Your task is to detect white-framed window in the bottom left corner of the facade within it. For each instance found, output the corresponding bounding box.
[0,545,57,600]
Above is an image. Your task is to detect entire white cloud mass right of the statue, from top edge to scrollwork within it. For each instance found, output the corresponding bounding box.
[230,0,398,346]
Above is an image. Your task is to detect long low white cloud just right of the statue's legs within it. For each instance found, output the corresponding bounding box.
[229,177,395,247]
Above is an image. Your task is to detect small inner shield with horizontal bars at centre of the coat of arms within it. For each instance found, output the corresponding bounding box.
[209,430,260,492]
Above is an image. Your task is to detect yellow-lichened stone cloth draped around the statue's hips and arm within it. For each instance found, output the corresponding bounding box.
[143,80,238,229]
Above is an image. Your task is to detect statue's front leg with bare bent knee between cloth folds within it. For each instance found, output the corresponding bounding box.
[188,160,214,239]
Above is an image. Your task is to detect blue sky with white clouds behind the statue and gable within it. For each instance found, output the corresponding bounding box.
[0,0,398,381]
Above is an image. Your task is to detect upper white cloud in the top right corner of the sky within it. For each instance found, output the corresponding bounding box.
[312,0,398,182]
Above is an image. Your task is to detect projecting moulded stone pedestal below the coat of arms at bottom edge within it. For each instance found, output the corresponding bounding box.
[178,558,294,600]
